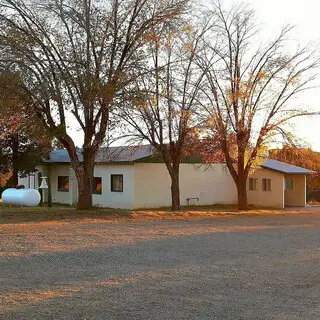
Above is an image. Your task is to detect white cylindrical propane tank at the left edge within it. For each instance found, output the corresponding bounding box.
[2,188,41,207]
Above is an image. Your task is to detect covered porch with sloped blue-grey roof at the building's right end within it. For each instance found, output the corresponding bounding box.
[262,159,313,207]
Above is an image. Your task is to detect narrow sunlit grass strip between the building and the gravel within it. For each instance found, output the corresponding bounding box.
[0,203,320,224]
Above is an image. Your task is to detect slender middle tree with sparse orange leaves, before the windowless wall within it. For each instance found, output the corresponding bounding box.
[116,17,209,210]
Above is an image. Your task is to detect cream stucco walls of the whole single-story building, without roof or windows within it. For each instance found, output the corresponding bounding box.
[19,163,305,209]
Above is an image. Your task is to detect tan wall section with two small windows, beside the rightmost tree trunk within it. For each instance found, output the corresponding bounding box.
[247,168,284,208]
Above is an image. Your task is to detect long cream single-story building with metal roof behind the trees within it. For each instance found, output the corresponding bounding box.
[19,146,312,209]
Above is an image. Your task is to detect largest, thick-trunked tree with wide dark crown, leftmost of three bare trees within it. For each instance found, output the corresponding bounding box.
[0,0,187,209]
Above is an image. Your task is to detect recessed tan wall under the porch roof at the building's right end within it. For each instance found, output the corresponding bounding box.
[285,174,306,207]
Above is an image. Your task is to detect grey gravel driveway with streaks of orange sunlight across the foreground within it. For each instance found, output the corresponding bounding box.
[0,213,320,320]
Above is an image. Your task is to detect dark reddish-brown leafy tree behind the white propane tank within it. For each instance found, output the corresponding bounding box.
[0,70,51,187]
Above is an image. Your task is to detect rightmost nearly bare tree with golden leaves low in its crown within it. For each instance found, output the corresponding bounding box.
[201,1,319,209]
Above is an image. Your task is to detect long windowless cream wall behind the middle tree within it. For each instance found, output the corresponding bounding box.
[134,163,237,208]
